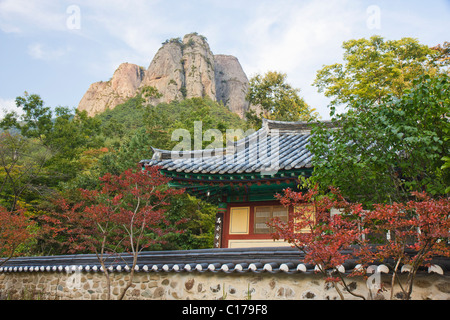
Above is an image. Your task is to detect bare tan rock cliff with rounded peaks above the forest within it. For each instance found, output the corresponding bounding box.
[78,33,249,117]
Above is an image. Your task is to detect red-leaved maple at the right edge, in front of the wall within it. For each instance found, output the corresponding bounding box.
[359,192,450,300]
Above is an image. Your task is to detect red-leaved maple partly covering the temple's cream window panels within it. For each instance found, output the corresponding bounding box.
[270,188,367,299]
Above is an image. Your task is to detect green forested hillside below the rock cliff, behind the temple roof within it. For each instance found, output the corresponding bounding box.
[0,87,247,254]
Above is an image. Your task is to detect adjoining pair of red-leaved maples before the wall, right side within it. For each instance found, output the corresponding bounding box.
[271,188,450,299]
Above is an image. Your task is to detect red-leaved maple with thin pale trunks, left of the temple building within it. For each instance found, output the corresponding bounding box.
[47,167,184,300]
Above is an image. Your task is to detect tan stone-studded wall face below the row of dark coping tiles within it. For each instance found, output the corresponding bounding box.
[0,272,450,300]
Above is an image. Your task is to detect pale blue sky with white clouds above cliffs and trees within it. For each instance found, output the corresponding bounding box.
[0,0,450,120]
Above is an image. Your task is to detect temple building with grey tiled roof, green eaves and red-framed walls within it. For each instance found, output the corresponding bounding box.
[141,119,334,248]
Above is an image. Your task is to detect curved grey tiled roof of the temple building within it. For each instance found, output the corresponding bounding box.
[141,119,338,174]
